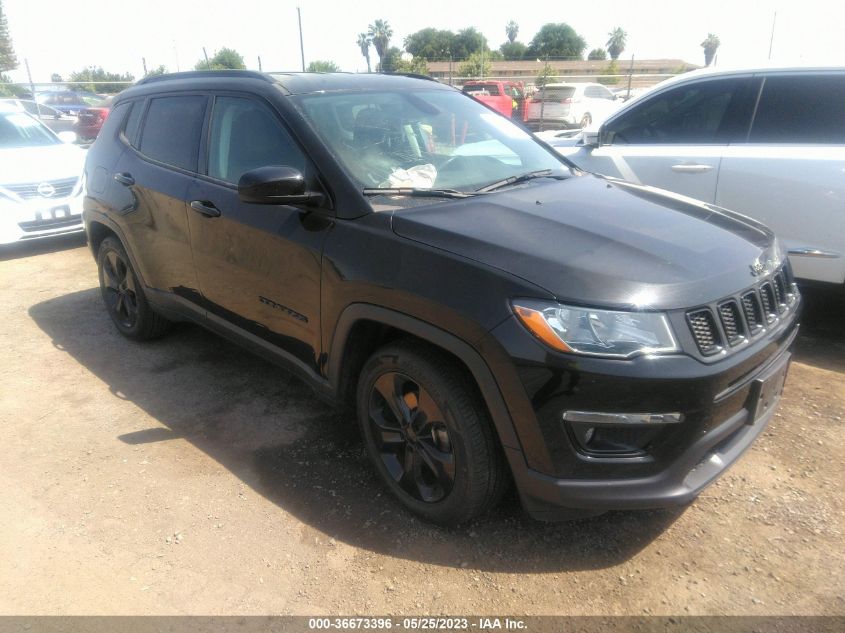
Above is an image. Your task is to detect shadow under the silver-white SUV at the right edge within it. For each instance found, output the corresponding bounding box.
[795,284,845,373]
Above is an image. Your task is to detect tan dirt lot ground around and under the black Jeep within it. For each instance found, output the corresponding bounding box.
[0,239,845,615]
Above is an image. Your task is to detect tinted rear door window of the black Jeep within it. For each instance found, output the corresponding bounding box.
[138,95,208,171]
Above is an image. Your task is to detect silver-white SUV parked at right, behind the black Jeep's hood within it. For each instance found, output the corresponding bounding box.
[552,68,845,284]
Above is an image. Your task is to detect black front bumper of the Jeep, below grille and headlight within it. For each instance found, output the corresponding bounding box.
[484,296,800,520]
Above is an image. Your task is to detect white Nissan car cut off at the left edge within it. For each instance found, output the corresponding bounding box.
[0,104,85,244]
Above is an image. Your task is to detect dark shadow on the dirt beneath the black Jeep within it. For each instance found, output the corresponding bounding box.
[29,288,683,573]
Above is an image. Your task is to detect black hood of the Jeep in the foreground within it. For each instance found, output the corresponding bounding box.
[393,175,782,309]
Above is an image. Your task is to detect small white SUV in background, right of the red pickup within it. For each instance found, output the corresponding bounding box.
[526,83,621,129]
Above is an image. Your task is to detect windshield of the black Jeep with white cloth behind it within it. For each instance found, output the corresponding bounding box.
[295,90,570,192]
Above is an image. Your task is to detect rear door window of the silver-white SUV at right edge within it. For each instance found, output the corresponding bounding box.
[749,74,845,144]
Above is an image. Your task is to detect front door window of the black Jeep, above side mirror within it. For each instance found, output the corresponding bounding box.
[208,97,306,183]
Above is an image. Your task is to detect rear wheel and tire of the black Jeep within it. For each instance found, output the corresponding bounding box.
[97,237,172,341]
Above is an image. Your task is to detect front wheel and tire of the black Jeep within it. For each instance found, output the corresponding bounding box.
[357,342,507,526]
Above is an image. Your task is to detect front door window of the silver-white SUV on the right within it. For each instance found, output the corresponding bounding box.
[603,78,759,144]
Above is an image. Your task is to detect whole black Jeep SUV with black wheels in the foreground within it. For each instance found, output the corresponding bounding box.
[84,71,801,525]
